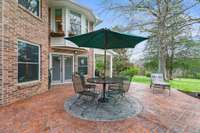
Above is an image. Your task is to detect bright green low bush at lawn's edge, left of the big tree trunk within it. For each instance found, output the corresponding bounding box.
[120,67,140,77]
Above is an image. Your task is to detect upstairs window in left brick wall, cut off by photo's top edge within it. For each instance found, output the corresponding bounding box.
[18,0,40,16]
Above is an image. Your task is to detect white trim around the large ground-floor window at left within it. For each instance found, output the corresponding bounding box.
[17,39,41,85]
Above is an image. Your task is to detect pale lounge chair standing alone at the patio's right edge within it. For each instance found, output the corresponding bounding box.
[150,73,171,96]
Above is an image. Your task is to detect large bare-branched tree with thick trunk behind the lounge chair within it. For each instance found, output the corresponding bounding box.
[104,0,200,78]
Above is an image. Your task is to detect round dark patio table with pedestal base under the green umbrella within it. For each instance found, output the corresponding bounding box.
[87,78,120,103]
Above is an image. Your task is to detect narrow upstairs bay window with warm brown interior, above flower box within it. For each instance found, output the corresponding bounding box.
[55,8,63,33]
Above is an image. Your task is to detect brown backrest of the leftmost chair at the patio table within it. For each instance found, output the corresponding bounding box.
[72,73,84,93]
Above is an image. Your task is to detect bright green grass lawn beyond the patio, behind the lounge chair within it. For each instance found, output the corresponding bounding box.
[133,76,200,92]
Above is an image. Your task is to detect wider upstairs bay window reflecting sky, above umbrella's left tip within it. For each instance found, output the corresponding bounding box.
[70,11,81,35]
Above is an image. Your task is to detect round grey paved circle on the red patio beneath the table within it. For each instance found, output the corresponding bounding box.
[64,95,143,121]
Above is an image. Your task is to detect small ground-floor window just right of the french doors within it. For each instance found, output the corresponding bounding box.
[78,56,88,75]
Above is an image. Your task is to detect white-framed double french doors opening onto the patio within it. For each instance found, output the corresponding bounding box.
[52,54,74,84]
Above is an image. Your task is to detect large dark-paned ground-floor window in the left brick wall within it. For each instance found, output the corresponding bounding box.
[18,41,40,83]
